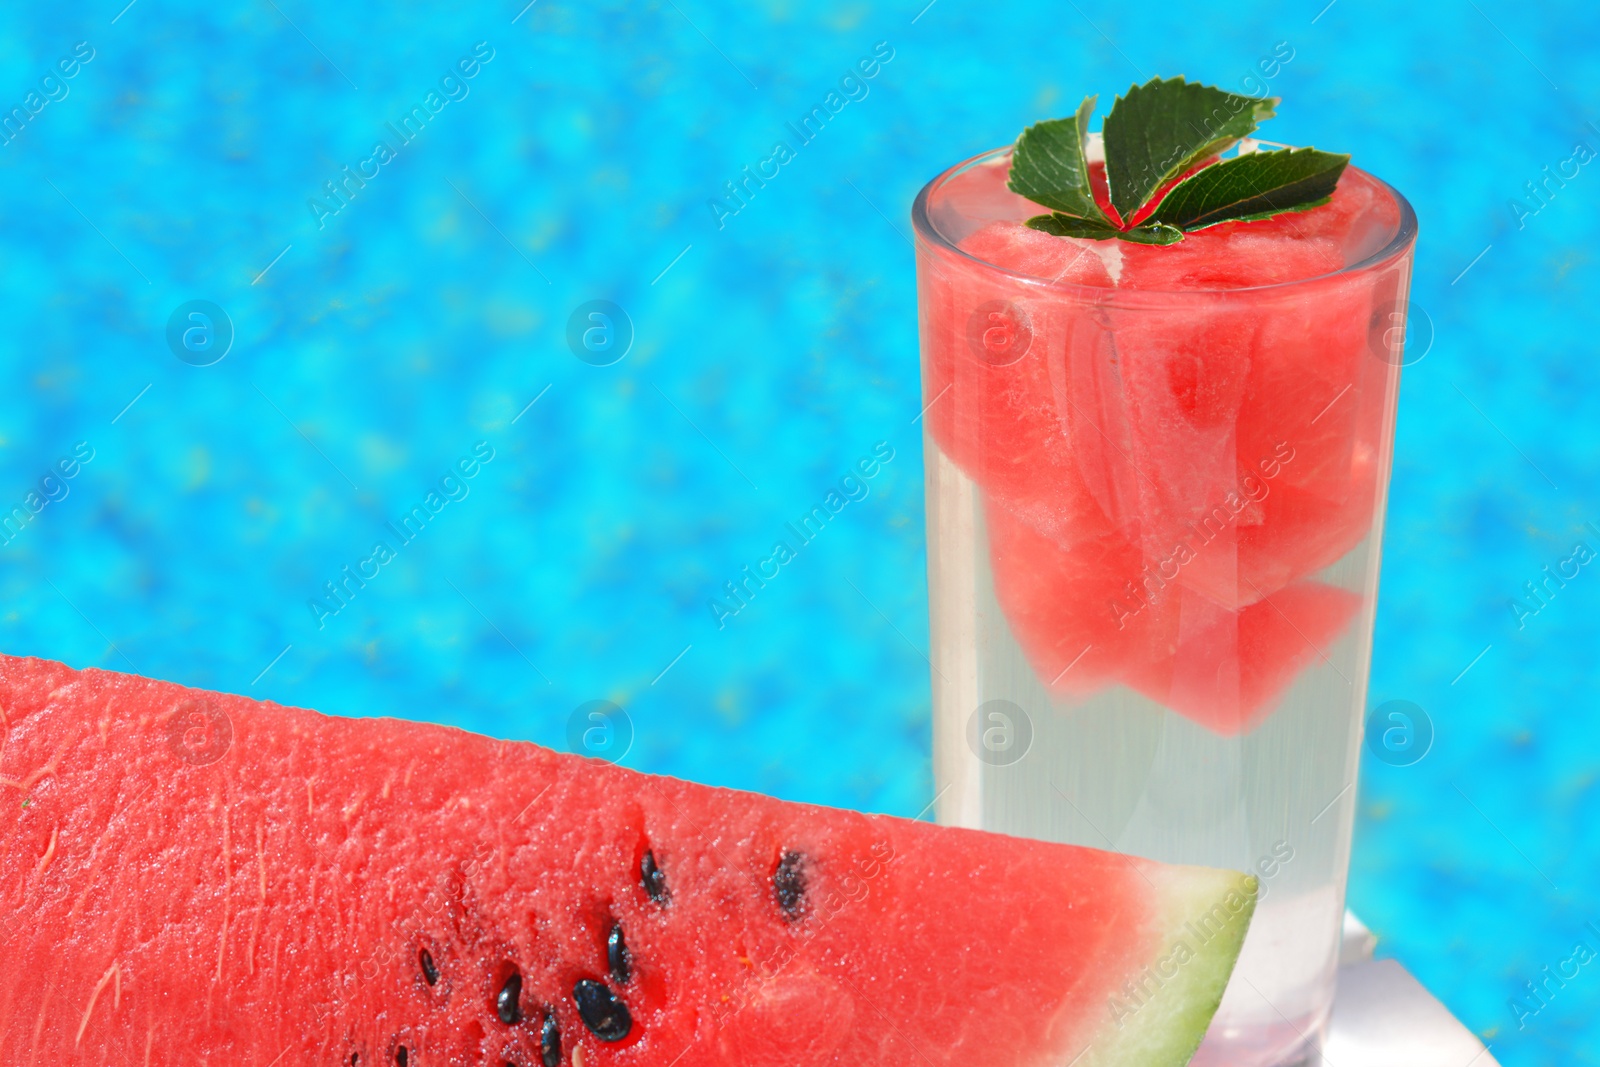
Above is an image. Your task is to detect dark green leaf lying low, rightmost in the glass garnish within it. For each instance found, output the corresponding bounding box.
[1147,149,1350,234]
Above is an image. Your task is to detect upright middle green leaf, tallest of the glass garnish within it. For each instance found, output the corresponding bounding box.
[1100,77,1278,219]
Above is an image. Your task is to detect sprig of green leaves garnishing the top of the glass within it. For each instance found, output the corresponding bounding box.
[1006,77,1350,245]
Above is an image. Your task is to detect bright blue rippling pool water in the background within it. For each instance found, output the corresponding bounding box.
[0,0,1600,1067]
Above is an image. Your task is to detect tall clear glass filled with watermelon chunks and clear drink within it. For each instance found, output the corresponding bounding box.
[912,149,1416,1067]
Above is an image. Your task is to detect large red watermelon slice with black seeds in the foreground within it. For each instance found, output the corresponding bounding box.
[0,657,1256,1067]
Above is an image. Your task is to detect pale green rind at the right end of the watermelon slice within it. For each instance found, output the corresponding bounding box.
[1062,862,1259,1067]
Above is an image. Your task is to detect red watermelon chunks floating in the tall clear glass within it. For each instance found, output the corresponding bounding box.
[920,151,1403,733]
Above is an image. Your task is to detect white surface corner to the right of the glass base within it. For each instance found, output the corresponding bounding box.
[1320,912,1499,1067]
